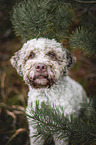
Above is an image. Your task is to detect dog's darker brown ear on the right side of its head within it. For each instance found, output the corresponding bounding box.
[66,50,76,70]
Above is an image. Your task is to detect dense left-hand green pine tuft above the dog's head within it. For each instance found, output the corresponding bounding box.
[12,0,50,39]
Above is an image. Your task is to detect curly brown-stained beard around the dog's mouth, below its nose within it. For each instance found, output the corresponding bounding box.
[23,66,60,89]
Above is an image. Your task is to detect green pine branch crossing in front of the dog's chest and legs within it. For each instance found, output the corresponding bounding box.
[27,102,96,145]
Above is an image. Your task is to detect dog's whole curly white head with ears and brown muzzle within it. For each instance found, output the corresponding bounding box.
[11,38,74,88]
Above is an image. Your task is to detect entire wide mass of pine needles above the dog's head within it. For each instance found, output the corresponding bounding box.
[12,0,74,40]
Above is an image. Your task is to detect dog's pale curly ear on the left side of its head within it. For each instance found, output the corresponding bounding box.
[10,50,23,76]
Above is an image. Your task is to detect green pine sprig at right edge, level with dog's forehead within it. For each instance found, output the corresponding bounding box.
[70,27,96,56]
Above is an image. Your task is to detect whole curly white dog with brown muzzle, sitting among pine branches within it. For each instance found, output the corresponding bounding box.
[11,38,86,145]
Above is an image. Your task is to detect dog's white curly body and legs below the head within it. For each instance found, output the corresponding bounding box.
[26,76,86,145]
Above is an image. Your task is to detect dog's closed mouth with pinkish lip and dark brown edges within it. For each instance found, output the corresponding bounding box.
[29,75,55,88]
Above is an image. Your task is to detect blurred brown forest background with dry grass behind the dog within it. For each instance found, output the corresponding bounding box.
[0,0,96,145]
